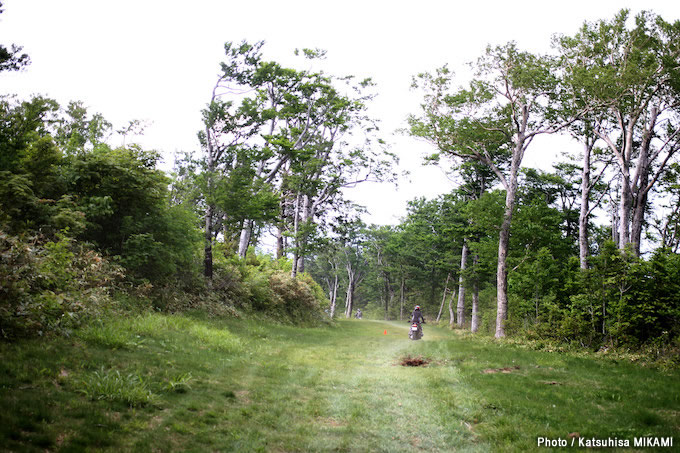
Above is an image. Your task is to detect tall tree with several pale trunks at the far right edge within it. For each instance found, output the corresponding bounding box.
[559,10,680,255]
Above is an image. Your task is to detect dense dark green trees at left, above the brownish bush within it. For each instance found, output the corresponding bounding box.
[0,97,200,282]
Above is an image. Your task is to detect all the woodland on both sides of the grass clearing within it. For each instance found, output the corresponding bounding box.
[0,6,680,353]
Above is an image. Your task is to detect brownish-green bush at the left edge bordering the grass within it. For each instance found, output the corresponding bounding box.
[0,230,122,339]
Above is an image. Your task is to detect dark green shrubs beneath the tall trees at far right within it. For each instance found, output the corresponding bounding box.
[511,242,680,349]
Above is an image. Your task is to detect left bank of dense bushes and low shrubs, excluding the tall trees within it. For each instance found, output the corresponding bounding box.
[0,93,336,339]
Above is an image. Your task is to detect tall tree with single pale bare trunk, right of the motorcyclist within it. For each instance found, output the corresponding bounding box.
[409,43,573,337]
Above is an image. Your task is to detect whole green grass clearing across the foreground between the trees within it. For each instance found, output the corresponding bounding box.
[0,314,680,452]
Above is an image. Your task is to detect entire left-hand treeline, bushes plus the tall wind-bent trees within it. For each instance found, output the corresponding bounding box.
[0,36,366,339]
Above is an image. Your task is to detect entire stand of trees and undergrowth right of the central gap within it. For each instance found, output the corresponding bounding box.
[306,10,680,352]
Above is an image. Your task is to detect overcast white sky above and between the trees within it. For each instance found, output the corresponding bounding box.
[0,0,680,223]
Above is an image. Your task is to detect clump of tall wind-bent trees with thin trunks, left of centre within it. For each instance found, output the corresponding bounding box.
[200,42,394,276]
